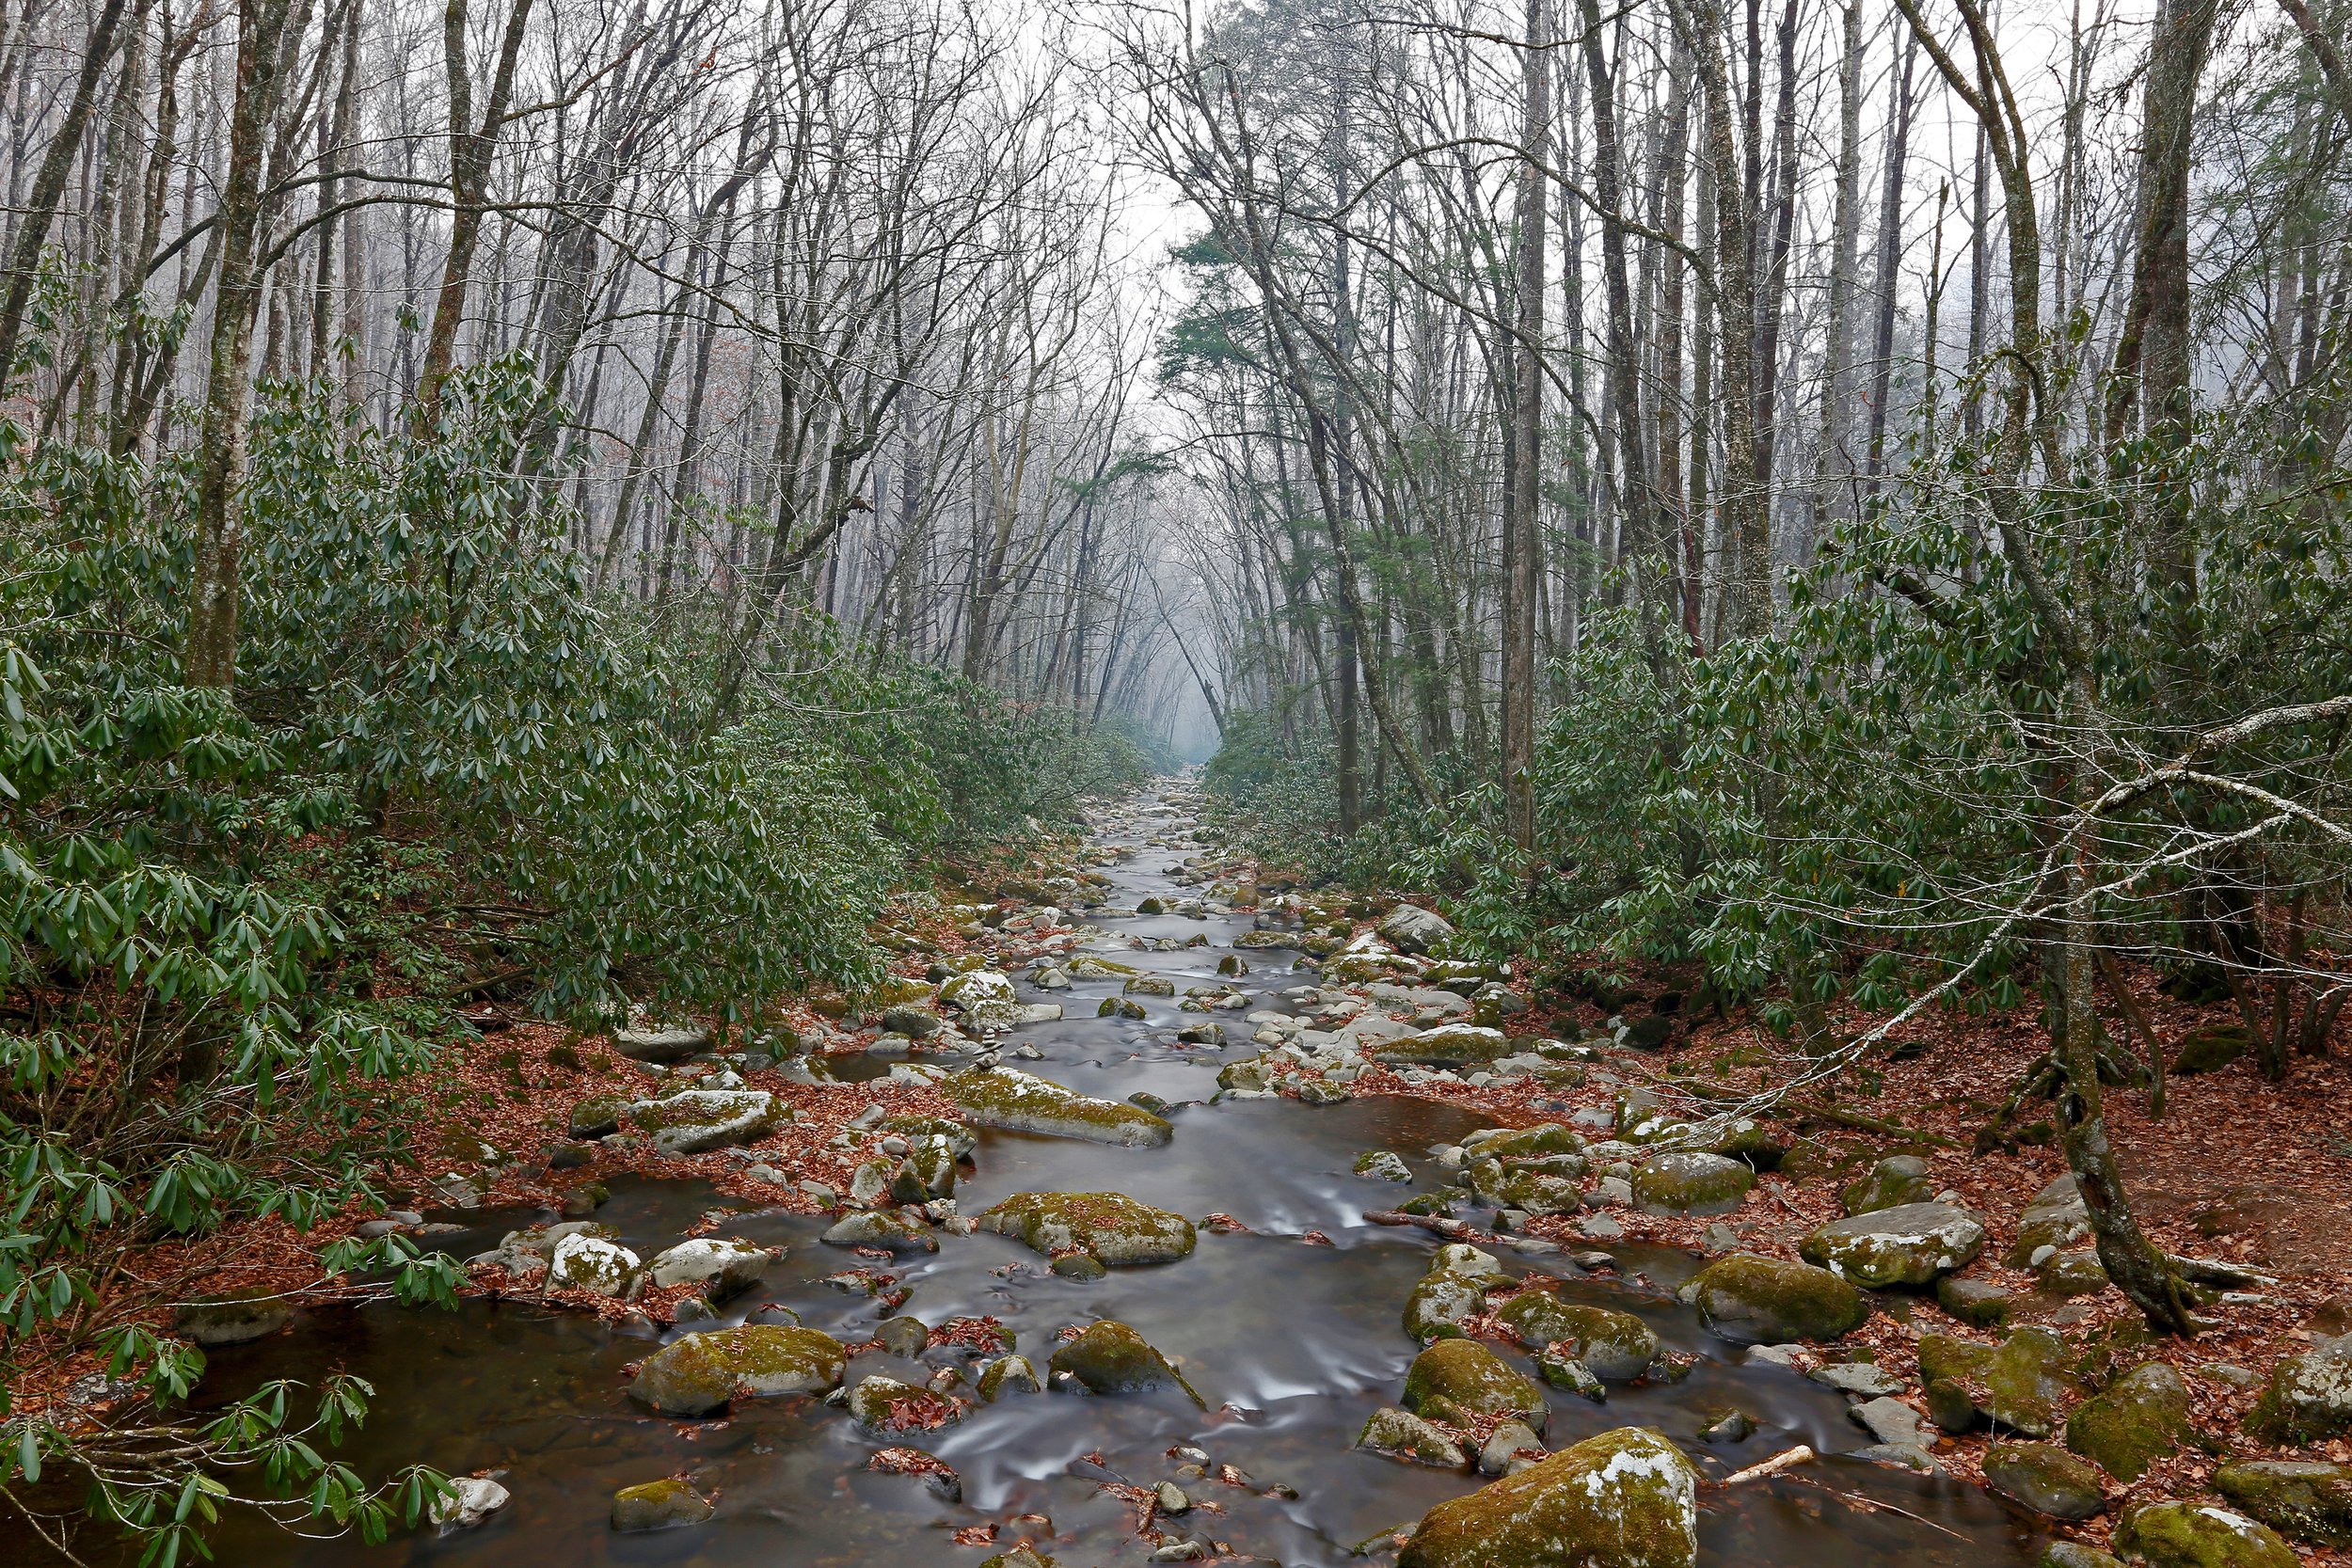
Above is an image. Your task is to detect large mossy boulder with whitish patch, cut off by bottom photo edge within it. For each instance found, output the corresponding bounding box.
[1397,1427,1698,1568]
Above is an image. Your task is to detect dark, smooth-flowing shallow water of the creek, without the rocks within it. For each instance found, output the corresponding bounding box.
[41,801,2037,1568]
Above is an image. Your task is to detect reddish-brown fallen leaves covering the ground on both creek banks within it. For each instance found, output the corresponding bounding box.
[14,784,2352,1566]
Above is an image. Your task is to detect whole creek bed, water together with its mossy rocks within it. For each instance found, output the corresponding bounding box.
[41,797,2294,1568]
